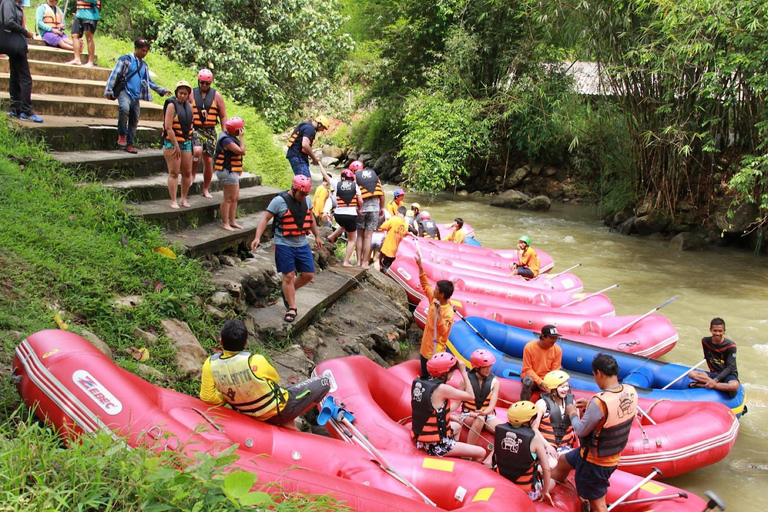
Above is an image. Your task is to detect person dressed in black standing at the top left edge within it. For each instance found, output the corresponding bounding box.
[0,0,43,123]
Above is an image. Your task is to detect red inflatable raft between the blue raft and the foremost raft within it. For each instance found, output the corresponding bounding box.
[317,356,739,480]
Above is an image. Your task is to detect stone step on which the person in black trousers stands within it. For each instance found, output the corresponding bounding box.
[13,115,162,151]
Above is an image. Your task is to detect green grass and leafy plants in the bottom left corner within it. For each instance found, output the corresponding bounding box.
[0,410,347,512]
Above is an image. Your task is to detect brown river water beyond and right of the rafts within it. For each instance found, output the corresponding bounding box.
[400,187,768,512]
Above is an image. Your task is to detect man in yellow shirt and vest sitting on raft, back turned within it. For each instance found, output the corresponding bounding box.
[200,320,331,428]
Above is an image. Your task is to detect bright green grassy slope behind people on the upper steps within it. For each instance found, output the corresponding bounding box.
[95,33,293,189]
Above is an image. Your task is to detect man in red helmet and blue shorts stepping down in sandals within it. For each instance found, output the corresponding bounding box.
[251,174,323,322]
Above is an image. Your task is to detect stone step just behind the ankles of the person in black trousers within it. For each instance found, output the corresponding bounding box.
[0,92,163,121]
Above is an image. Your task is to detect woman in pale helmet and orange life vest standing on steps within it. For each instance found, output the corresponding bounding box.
[163,80,192,210]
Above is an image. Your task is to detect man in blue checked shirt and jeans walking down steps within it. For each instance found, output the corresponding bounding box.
[104,37,171,153]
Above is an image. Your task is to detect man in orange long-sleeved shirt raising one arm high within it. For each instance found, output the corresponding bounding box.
[416,253,455,377]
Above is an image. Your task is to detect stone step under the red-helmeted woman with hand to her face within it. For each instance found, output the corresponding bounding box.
[166,210,264,258]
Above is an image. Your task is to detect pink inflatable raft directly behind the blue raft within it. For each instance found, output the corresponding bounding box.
[413,297,678,359]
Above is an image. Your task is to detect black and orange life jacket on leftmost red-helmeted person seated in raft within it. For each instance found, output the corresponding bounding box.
[411,377,453,443]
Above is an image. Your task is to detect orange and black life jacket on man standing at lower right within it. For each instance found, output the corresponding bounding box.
[581,384,637,467]
